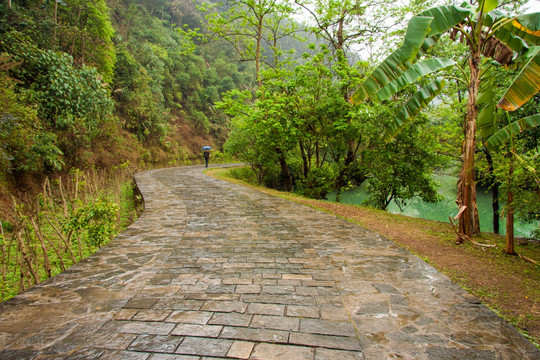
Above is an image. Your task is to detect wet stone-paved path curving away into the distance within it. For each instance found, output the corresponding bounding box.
[0,166,540,360]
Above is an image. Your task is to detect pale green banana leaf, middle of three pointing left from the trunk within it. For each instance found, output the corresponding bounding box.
[374,58,456,101]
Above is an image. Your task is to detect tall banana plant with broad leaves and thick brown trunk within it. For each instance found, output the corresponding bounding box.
[351,0,540,241]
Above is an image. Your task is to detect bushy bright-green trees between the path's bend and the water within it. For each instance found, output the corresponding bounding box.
[218,44,440,209]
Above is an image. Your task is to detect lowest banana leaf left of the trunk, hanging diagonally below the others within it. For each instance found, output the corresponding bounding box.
[385,79,445,140]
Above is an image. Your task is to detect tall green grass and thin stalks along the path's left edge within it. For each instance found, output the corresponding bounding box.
[0,164,138,301]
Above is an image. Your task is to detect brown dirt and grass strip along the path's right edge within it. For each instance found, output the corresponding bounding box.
[207,169,540,347]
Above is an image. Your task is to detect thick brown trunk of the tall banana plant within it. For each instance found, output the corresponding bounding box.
[456,55,480,236]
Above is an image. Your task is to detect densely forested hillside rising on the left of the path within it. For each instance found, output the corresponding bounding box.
[0,0,255,191]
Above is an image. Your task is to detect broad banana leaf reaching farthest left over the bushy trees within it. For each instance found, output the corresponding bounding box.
[351,16,433,104]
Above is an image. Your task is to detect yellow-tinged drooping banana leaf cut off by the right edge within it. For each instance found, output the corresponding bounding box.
[497,46,540,111]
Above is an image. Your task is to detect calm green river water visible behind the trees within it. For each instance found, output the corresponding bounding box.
[328,174,540,237]
